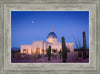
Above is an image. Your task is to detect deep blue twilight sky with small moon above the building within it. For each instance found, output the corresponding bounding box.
[11,11,89,48]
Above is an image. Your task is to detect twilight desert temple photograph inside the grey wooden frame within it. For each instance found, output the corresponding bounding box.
[11,11,89,63]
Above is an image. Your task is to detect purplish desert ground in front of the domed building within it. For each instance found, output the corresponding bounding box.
[11,51,89,63]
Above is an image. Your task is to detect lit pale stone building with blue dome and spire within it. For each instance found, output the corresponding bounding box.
[20,29,74,54]
